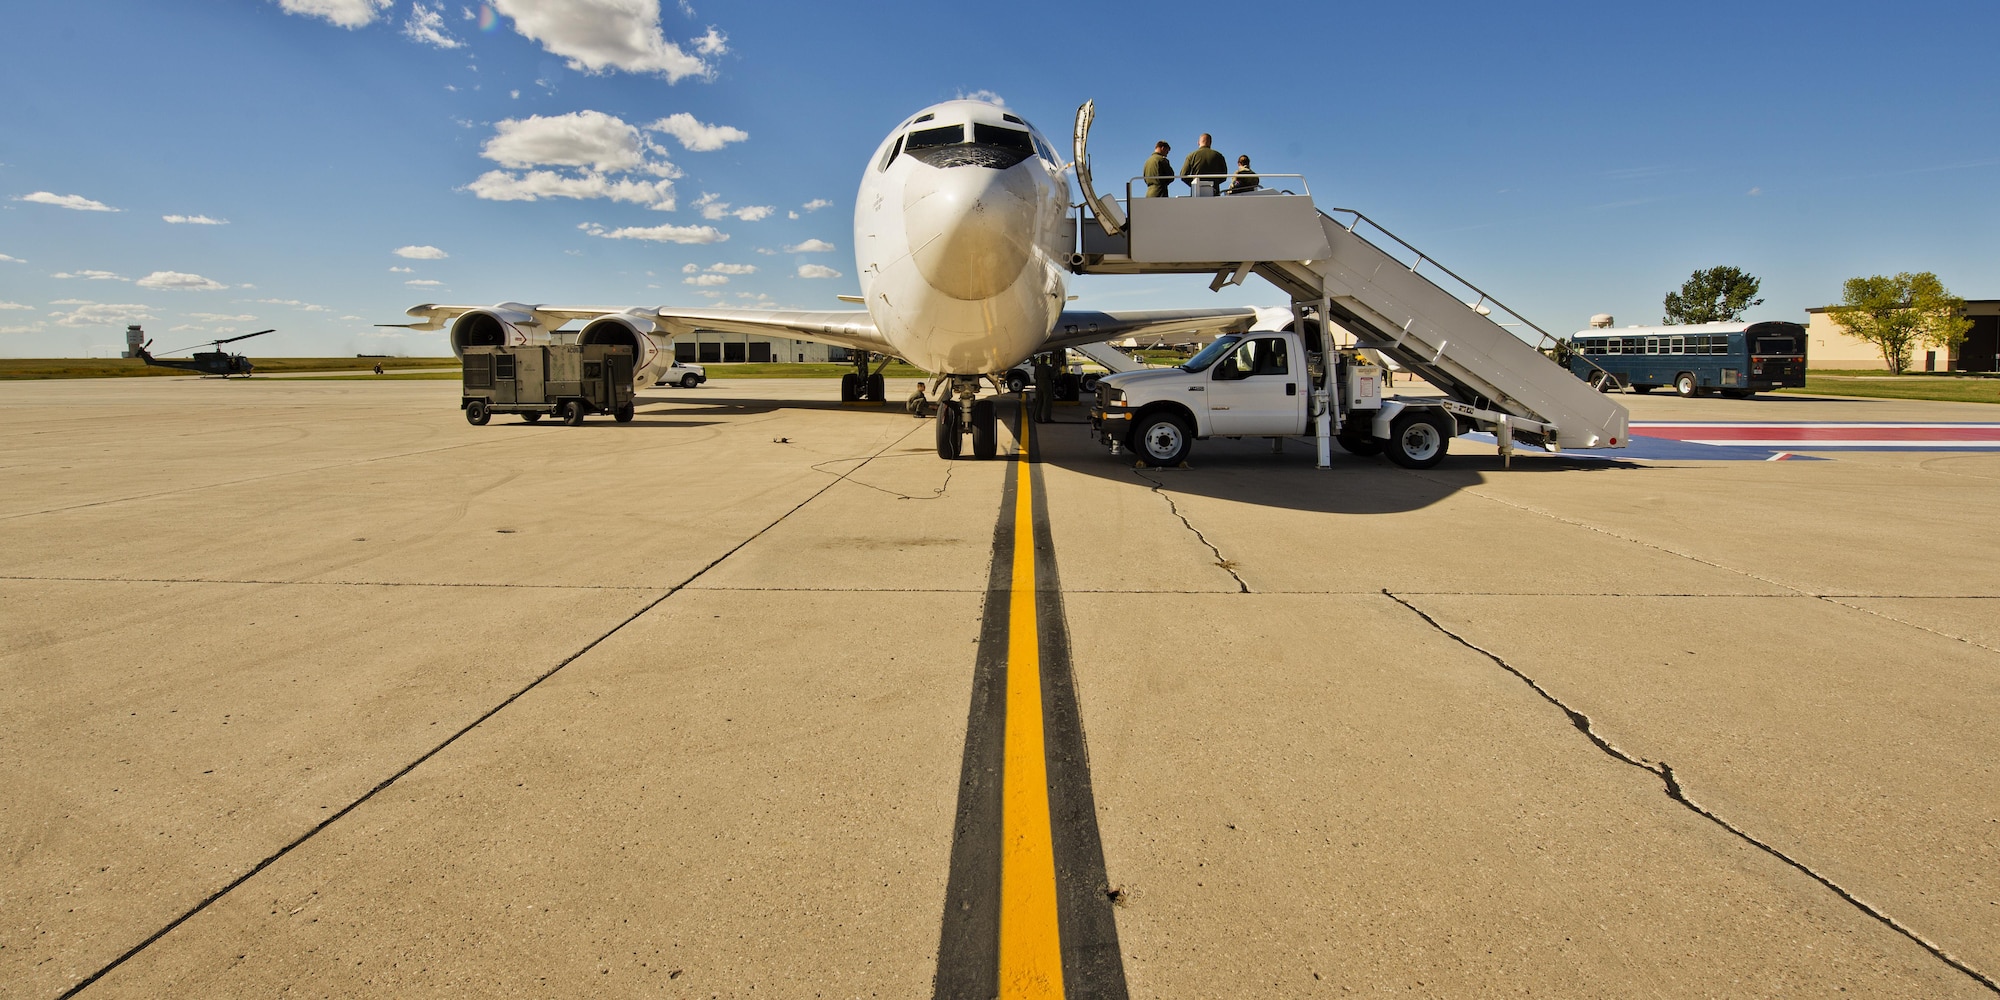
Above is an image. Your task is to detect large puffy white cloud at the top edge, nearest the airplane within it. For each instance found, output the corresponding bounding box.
[492,0,728,84]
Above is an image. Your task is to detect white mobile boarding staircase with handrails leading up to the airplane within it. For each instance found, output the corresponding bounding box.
[1070,104,1628,460]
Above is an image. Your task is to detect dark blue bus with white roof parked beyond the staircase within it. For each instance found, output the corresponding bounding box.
[1566,322,1806,398]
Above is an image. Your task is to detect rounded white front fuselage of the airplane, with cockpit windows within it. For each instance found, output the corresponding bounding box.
[854,100,1072,376]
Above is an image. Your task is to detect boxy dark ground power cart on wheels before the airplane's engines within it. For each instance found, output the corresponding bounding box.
[458,344,634,426]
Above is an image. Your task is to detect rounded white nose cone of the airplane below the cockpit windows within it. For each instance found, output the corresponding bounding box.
[902,166,1036,300]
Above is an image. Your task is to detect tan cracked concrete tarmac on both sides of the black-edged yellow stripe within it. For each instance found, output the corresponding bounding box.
[0,378,2000,1000]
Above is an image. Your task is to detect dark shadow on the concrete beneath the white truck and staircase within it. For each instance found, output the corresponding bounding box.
[1036,414,1648,514]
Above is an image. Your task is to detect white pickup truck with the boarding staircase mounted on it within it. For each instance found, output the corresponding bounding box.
[1090,330,1474,468]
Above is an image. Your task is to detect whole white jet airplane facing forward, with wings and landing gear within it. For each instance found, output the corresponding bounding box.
[384,100,1256,458]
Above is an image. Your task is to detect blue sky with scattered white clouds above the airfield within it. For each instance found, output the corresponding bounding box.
[0,0,2000,356]
